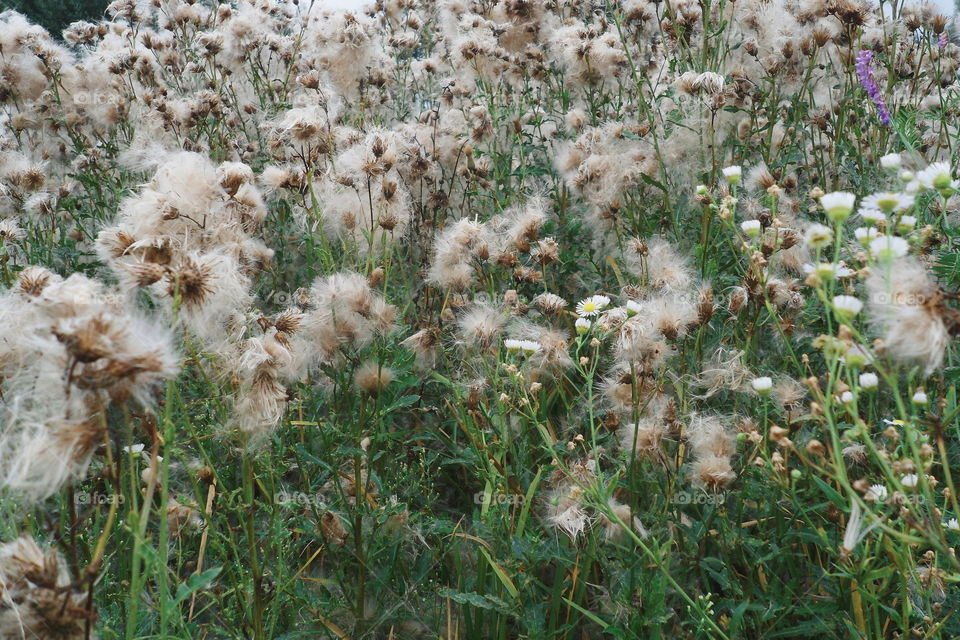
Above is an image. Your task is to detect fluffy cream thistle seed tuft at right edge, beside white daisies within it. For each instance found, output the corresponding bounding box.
[867,258,956,375]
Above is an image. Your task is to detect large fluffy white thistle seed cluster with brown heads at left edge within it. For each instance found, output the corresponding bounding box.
[0,269,179,499]
